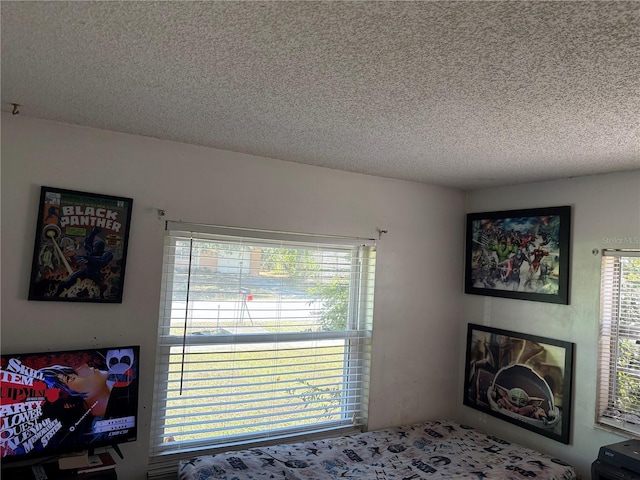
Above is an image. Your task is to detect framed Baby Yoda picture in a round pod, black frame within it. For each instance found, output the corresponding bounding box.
[463,324,574,444]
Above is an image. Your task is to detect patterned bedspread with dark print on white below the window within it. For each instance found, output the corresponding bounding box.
[178,421,576,480]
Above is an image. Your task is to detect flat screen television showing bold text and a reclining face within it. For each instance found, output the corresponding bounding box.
[0,346,140,463]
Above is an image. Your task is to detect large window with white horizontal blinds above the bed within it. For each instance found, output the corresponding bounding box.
[151,223,375,457]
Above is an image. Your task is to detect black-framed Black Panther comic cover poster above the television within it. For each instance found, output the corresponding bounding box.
[29,187,133,303]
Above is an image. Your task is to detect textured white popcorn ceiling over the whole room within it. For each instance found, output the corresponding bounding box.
[1,1,640,189]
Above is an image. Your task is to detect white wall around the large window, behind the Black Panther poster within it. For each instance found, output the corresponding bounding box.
[1,115,464,480]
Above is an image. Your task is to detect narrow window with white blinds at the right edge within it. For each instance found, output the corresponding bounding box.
[597,250,640,436]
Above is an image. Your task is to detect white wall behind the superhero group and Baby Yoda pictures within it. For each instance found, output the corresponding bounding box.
[458,171,640,479]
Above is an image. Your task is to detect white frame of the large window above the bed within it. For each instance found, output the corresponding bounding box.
[150,222,376,463]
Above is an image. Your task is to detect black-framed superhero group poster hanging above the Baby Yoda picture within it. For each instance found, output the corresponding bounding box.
[464,207,571,305]
